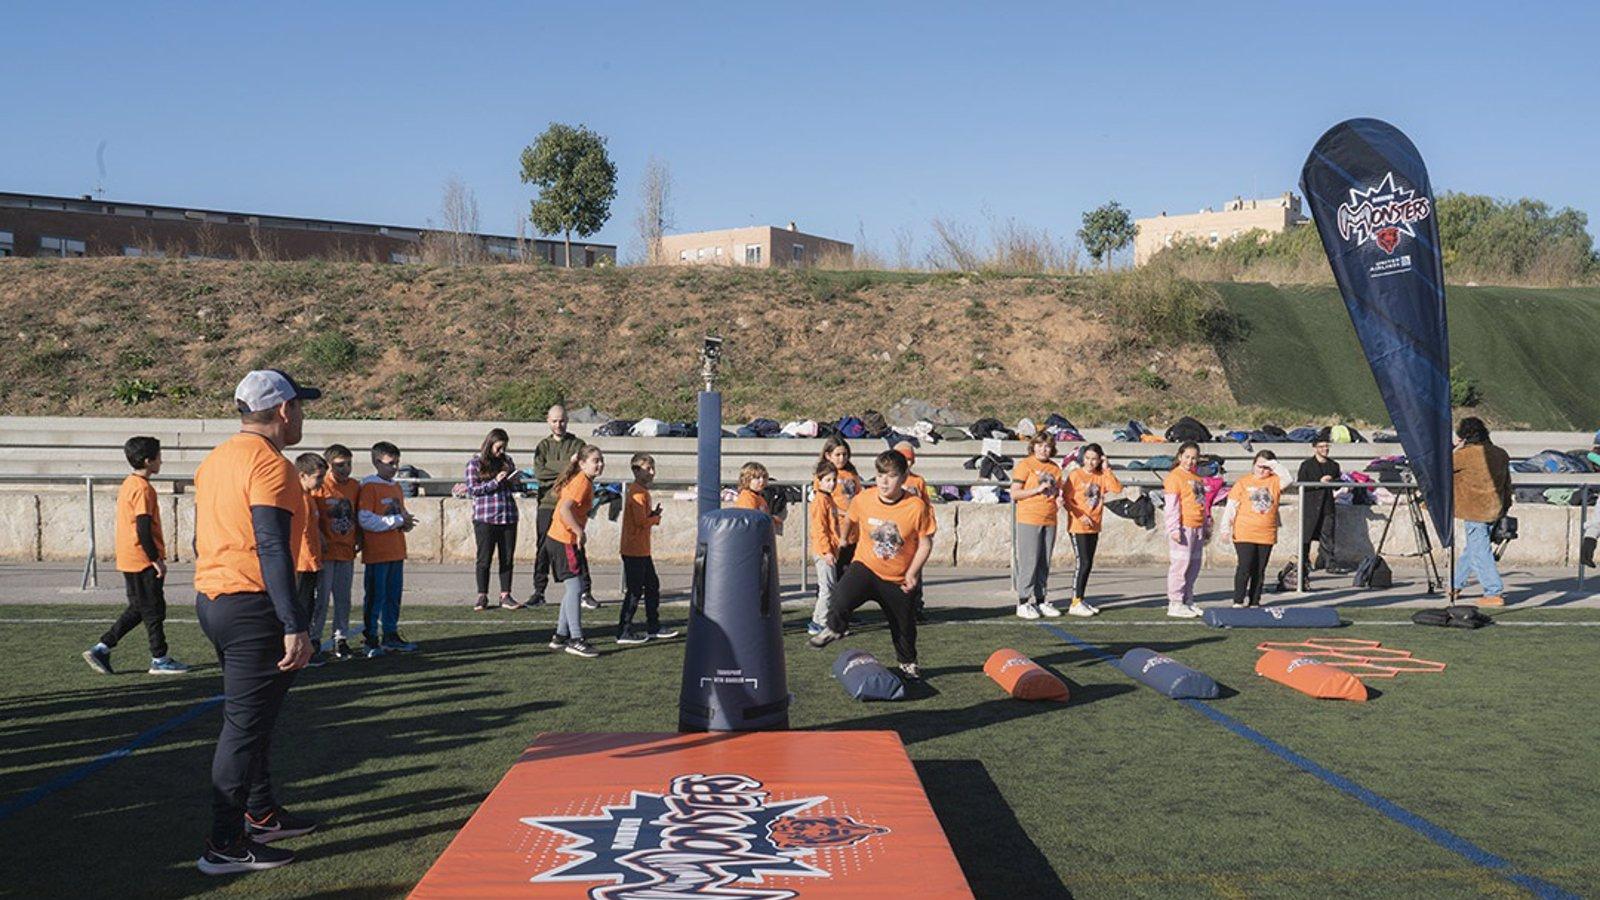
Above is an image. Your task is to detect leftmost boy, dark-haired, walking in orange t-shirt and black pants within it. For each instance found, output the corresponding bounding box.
[83,437,189,674]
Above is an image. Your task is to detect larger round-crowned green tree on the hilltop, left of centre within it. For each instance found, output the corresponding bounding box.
[522,122,616,267]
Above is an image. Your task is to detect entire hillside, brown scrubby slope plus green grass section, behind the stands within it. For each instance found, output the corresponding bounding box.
[0,259,1600,429]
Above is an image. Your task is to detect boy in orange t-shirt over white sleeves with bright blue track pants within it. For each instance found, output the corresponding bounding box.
[355,440,416,660]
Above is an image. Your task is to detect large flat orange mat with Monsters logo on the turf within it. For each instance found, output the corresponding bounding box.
[411,732,973,900]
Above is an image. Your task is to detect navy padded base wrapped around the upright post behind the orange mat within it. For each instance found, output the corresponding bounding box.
[678,509,790,732]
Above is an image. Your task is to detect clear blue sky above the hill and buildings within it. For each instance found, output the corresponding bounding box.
[0,0,1600,259]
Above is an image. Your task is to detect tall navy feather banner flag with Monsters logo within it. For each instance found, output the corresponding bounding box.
[1301,119,1454,546]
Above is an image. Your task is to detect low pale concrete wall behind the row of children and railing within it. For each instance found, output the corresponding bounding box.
[0,485,1579,570]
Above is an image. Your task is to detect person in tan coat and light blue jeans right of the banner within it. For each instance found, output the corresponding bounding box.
[1450,416,1510,607]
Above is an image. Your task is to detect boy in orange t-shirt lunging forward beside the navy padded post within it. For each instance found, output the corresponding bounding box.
[808,450,938,681]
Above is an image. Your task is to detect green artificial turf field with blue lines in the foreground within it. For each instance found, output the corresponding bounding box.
[0,607,1600,900]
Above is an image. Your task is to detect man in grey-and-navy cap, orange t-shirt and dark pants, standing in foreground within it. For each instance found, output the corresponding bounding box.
[195,368,322,874]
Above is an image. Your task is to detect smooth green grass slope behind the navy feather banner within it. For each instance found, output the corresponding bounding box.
[1216,283,1600,431]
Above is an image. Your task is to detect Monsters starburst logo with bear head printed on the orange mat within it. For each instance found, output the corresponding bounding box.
[522,775,890,900]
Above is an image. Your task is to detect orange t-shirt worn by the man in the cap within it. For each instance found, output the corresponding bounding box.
[195,432,306,601]
